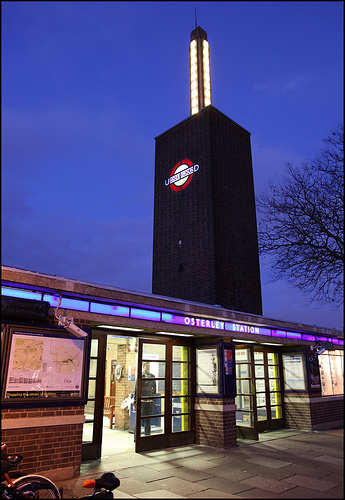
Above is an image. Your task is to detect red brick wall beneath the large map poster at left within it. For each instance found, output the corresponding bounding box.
[1,406,84,481]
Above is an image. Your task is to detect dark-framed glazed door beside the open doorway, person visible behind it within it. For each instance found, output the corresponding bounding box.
[134,339,195,452]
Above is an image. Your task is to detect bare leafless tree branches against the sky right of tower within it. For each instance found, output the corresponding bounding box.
[257,125,344,308]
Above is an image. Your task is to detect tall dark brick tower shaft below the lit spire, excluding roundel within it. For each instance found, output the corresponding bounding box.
[152,106,262,315]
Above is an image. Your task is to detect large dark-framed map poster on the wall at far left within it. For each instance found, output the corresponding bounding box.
[1,325,91,408]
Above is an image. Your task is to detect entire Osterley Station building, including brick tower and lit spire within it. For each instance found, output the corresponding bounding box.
[1,27,344,480]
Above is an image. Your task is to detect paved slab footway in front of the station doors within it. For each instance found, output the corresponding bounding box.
[57,429,344,499]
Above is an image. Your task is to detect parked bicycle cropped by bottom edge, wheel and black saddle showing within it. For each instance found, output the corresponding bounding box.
[1,443,120,500]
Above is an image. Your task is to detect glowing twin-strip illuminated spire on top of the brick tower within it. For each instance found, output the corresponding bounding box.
[189,26,212,115]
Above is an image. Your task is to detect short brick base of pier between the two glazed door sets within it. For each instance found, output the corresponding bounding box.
[195,398,237,448]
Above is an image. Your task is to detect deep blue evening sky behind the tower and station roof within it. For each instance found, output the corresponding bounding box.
[2,1,343,328]
